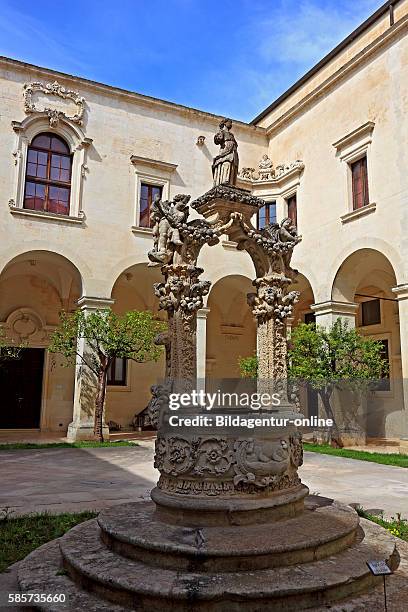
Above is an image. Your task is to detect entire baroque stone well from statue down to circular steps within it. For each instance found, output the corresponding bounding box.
[15,120,399,612]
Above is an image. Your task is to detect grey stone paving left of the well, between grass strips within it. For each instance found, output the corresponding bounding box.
[0,442,157,515]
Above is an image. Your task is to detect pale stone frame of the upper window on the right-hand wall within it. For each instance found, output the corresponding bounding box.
[333,121,376,224]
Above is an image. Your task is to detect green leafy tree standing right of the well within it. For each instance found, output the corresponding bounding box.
[288,318,388,446]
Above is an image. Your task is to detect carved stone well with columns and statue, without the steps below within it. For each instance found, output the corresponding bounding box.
[148,120,307,522]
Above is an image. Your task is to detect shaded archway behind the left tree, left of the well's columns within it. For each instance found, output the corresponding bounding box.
[105,263,167,430]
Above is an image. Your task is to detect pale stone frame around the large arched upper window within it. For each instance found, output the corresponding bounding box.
[9,113,92,223]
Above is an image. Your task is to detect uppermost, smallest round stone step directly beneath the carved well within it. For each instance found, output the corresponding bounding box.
[98,498,362,572]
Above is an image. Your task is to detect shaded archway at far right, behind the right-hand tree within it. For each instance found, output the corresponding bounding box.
[332,249,403,439]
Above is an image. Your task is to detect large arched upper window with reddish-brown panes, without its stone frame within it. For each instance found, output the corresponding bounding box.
[24,133,72,215]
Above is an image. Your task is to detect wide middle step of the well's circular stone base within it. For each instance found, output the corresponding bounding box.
[50,520,399,612]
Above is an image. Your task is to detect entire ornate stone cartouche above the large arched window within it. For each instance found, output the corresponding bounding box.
[23,81,85,127]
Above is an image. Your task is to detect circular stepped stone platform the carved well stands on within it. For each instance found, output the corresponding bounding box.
[18,496,399,612]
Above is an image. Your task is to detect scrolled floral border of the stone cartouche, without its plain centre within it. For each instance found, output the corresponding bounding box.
[23,81,85,127]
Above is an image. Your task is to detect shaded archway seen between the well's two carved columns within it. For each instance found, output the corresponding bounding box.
[206,275,256,379]
